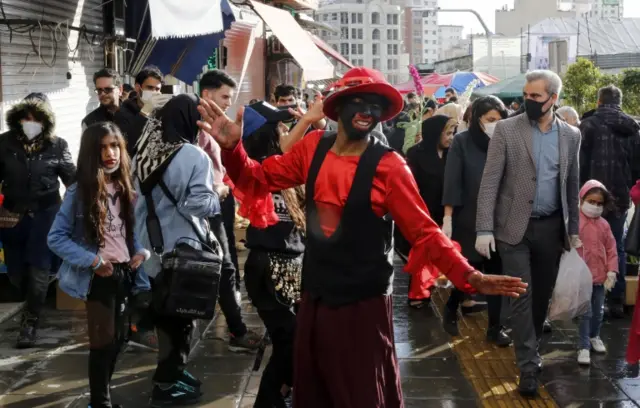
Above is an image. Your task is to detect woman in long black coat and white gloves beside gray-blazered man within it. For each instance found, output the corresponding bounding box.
[441,96,511,346]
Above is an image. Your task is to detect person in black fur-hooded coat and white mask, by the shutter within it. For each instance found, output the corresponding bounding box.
[0,93,76,348]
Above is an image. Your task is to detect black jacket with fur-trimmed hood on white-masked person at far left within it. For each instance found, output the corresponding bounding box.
[0,99,76,214]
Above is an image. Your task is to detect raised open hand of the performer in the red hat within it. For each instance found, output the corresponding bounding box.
[198,98,244,149]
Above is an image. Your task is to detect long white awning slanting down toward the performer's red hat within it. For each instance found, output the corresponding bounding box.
[251,0,334,81]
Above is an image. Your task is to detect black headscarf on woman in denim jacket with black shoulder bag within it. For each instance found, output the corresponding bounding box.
[156,94,200,144]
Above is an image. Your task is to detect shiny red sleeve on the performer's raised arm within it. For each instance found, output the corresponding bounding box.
[222,132,321,228]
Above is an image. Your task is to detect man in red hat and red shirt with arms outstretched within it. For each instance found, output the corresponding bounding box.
[199,68,526,408]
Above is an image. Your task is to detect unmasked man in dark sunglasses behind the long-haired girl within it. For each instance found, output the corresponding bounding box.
[82,68,122,131]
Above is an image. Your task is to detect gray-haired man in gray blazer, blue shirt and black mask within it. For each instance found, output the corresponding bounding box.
[476,71,582,396]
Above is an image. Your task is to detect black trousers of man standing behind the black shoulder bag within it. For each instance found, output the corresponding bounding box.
[209,214,247,337]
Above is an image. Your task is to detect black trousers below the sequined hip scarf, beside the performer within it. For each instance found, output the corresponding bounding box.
[244,250,296,408]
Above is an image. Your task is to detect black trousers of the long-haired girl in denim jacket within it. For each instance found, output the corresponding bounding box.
[86,264,133,408]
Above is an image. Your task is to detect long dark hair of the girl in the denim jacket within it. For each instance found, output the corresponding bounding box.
[77,122,135,251]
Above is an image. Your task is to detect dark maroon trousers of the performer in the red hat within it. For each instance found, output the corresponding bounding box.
[293,294,404,408]
